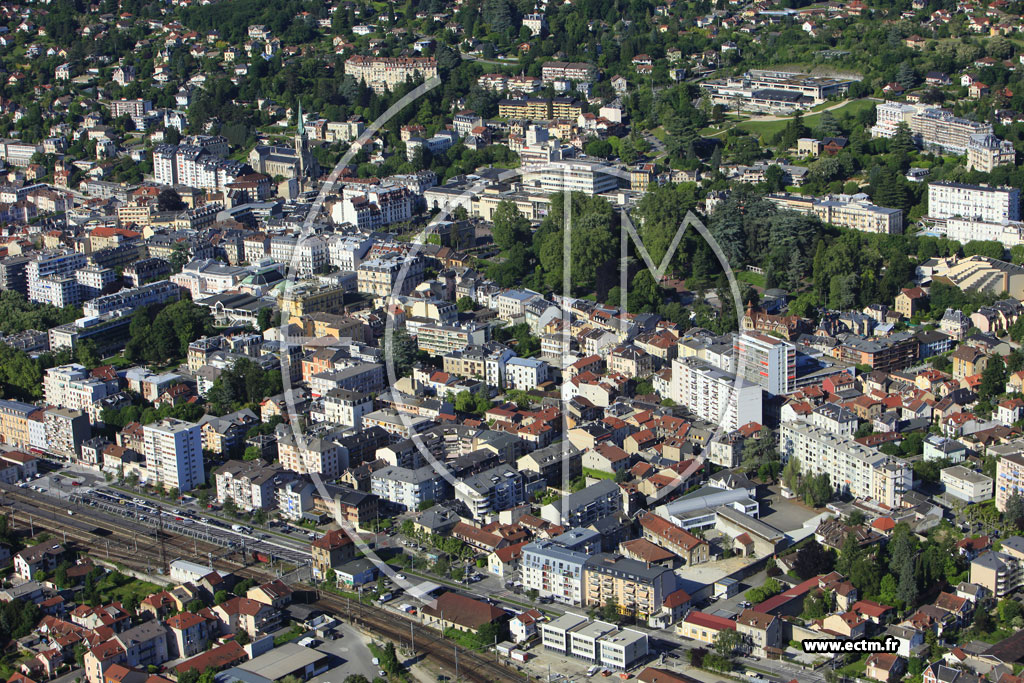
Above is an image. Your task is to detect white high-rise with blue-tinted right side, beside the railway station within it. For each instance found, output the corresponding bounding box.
[142,418,206,493]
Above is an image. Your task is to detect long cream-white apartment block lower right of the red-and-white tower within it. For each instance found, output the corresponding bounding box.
[779,421,911,507]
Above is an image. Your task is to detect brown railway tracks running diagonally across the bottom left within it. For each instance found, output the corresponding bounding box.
[0,486,528,683]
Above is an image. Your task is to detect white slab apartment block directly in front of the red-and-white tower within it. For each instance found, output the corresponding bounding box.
[670,357,764,431]
